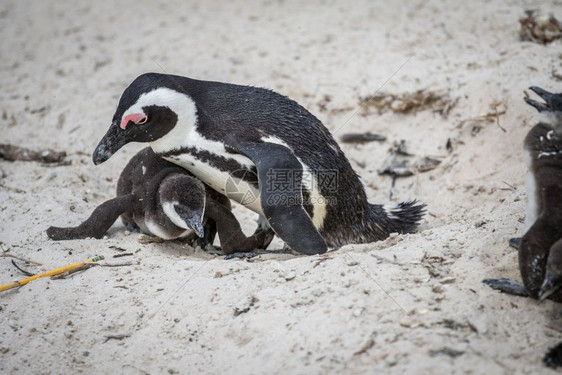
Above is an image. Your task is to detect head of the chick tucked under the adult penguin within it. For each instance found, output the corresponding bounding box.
[158,173,206,237]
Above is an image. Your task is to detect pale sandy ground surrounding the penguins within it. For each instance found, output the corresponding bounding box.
[0,0,562,374]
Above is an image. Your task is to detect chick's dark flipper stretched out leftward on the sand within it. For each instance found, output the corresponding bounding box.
[47,194,134,241]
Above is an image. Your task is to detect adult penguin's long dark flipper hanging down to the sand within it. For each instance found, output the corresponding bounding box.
[230,142,328,255]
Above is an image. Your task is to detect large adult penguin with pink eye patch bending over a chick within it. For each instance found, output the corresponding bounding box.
[93,73,425,254]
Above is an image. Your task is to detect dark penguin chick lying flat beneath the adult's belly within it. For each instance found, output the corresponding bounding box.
[47,148,273,254]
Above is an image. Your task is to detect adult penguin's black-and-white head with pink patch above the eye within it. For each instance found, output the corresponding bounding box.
[93,73,196,165]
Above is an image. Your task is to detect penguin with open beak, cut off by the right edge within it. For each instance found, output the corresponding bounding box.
[484,86,562,302]
